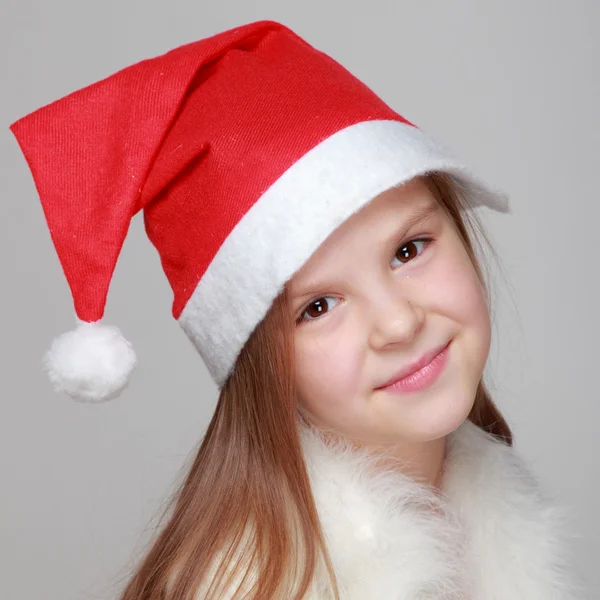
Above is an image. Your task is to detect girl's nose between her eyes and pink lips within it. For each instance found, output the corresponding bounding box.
[371,294,425,349]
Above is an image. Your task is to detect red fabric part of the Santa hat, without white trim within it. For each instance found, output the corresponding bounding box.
[11,21,410,321]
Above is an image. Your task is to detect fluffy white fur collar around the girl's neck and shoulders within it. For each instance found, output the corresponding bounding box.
[301,421,579,600]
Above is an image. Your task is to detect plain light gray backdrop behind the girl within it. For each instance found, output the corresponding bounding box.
[0,0,600,600]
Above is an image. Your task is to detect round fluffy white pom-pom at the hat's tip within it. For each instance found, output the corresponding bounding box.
[43,321,136,402]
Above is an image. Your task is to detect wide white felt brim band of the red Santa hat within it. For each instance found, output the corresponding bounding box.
[179,120,509,388]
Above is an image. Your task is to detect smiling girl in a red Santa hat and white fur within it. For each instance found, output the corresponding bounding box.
[11,21,575,600]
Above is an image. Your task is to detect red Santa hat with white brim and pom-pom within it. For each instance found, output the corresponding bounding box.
[11,21,509,401]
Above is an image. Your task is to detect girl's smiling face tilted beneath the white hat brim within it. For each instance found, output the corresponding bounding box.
[288,178,491,443]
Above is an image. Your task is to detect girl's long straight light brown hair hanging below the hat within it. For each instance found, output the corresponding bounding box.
[115,172,512,600]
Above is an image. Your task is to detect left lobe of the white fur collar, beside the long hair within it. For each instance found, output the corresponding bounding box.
[302,428,468,600]
